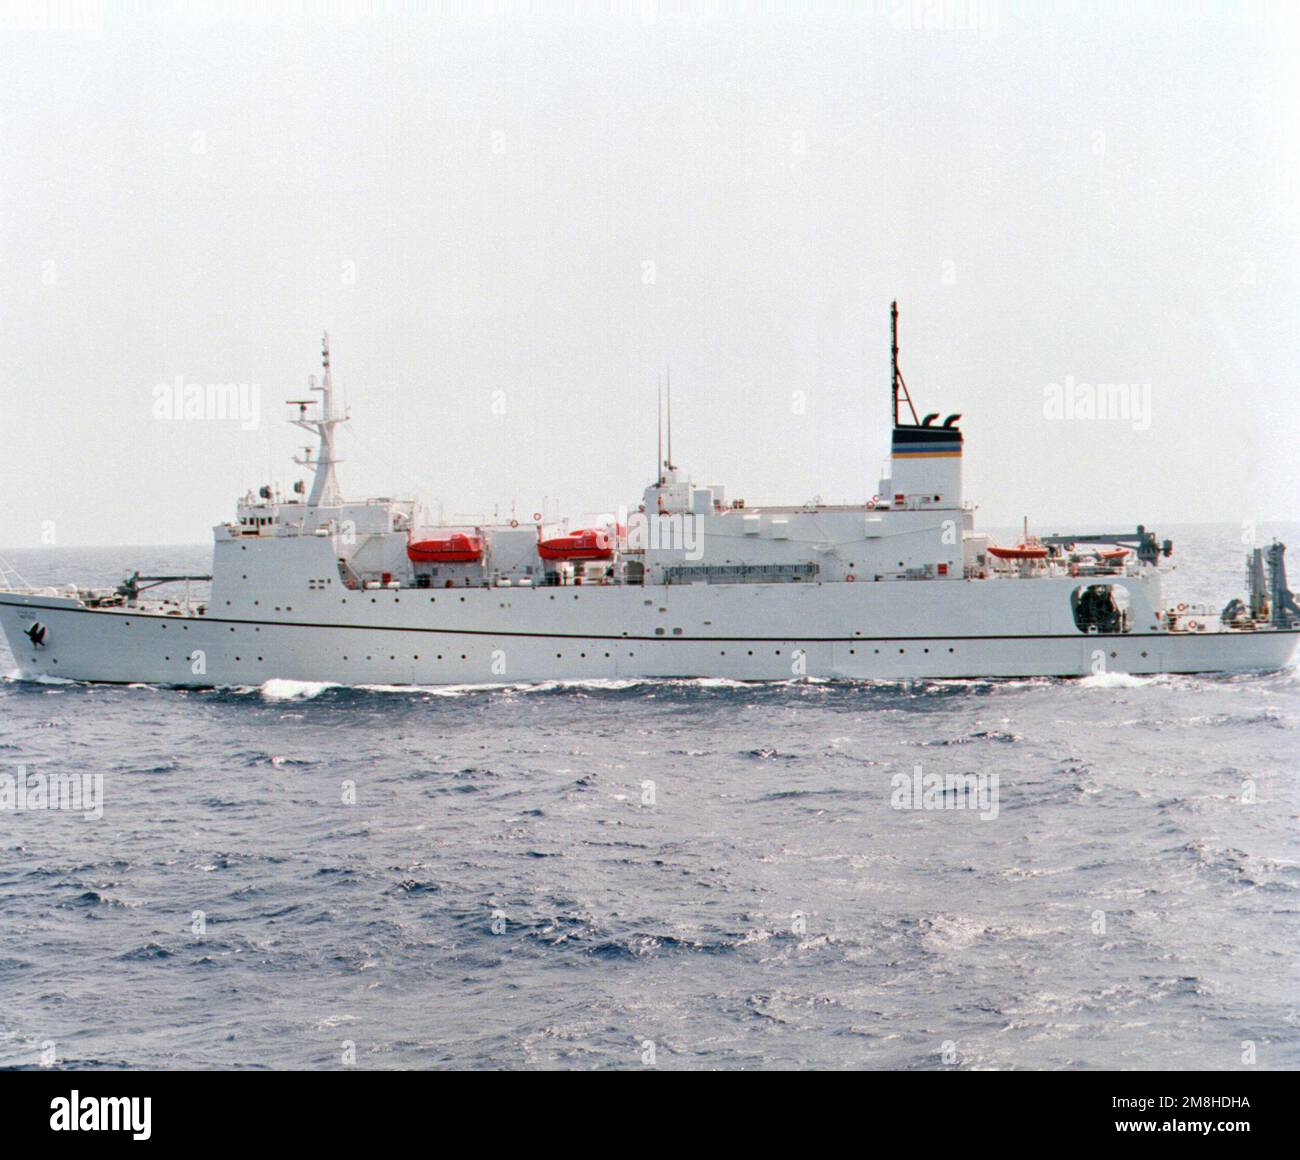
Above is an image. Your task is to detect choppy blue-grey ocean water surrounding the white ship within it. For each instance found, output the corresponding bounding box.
[0,528,1300,1069]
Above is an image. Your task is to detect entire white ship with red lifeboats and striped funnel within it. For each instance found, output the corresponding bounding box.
[0,307,1300,687]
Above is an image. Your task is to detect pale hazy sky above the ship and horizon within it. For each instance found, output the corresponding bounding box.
[0,0,1300,545]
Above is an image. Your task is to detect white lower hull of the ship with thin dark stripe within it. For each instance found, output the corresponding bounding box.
[0,585,1300,688]
